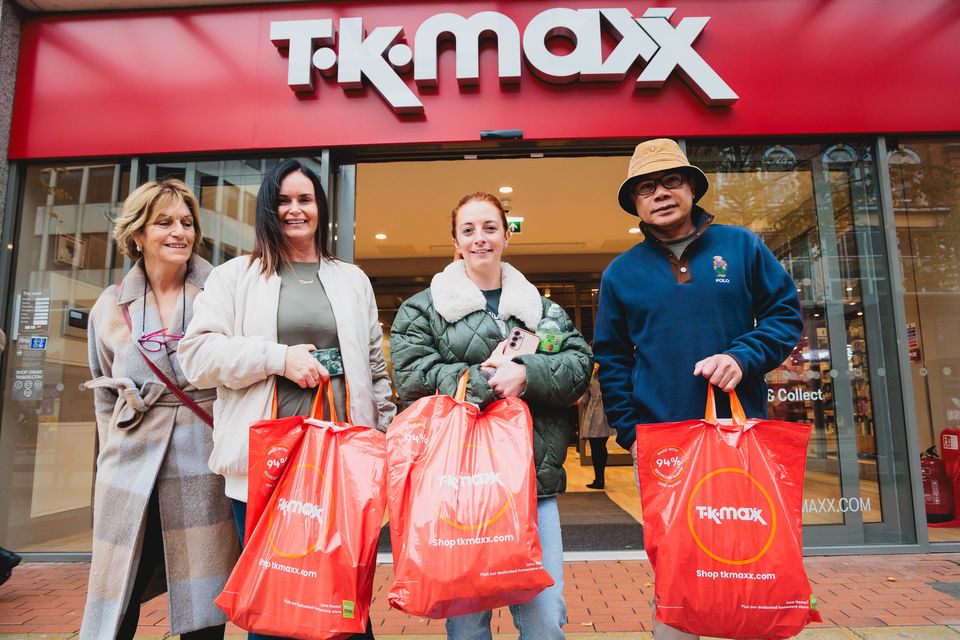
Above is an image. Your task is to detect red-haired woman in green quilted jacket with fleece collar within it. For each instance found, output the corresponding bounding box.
[390,192,593,640]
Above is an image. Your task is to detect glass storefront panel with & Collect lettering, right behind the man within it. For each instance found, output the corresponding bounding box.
[688,142,913,544]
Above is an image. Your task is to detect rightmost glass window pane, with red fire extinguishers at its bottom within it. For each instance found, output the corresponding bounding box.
[888,139,960,542]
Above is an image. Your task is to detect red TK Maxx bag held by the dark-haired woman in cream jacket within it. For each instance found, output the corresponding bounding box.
[216,382,386,640]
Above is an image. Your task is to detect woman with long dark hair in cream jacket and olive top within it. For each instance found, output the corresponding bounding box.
[180,159,396,639]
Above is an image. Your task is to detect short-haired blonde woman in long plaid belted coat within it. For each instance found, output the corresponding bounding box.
[80,180,239,640]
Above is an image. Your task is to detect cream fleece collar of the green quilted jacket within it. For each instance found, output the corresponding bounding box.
[430,260,543,330]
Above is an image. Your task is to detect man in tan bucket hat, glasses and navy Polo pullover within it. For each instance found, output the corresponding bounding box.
[593,139,803,640]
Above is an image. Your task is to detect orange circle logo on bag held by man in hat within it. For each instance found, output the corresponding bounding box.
[687,467,777,565]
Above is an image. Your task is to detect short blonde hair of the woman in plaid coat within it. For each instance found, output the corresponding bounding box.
[113,179,203,260]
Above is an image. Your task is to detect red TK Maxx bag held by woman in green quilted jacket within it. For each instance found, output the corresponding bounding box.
[387,377,553,618]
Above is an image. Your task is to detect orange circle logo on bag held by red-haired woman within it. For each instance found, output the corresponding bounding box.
[431,446,513,531]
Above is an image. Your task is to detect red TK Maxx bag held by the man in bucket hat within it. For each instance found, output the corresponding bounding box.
[637,387,820,639]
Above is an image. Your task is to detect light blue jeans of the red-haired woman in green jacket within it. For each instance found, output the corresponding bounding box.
[447,497,567,640]
